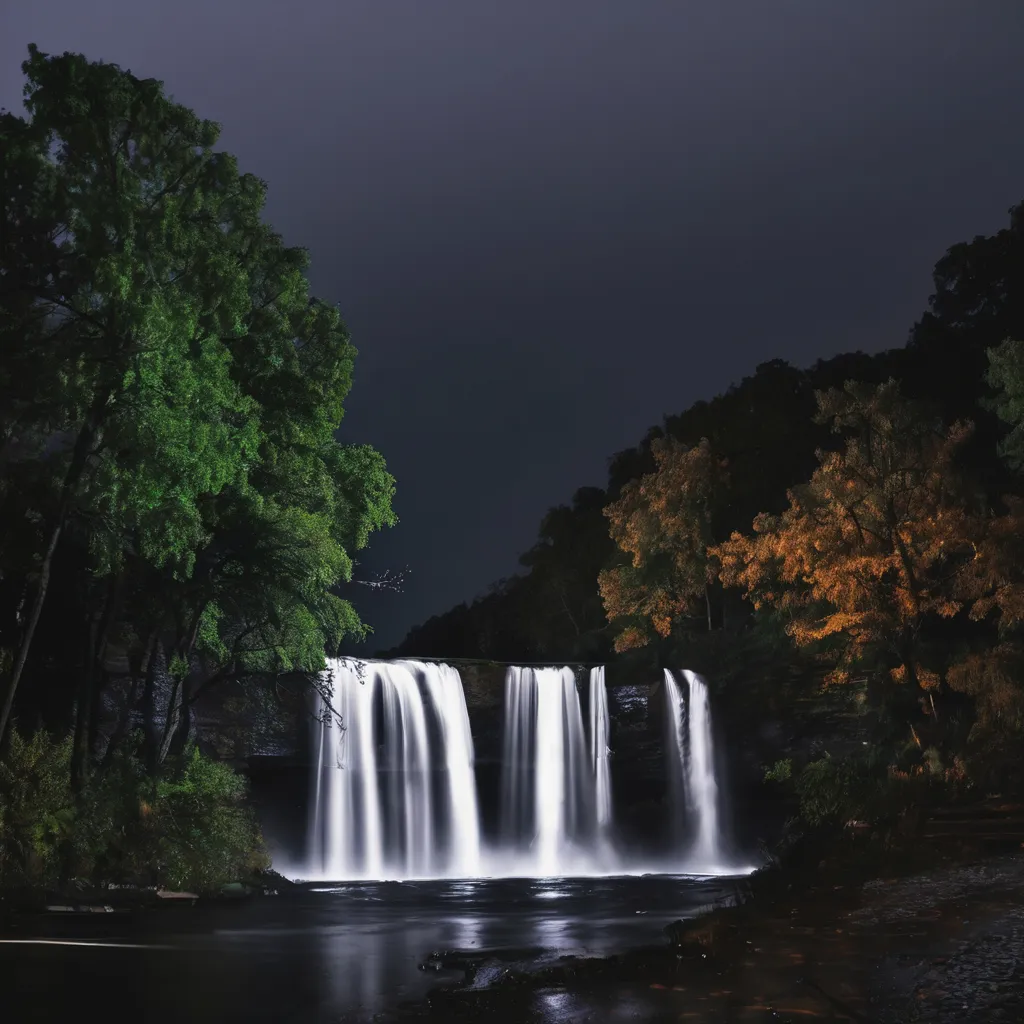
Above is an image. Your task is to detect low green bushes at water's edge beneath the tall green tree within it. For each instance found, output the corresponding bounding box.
[0,730,268,891]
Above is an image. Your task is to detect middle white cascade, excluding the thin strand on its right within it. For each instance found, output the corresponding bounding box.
[502,667,594,874]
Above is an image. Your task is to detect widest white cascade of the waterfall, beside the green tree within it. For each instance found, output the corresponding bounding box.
[309,659,480,880]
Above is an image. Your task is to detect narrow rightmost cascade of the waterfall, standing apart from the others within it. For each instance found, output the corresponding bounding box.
[665,669,723,870]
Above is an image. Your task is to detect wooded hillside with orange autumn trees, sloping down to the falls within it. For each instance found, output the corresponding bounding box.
[395,205,1024,838]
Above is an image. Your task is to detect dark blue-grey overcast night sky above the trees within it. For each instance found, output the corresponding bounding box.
[6,0,1024,648]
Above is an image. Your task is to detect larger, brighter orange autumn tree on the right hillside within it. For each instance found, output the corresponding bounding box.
[713,380,979,689]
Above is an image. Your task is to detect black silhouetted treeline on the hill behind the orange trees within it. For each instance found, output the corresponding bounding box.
[392,205,1024,664]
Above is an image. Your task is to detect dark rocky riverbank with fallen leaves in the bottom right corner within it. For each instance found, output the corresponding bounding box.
[398,807,1024,1024]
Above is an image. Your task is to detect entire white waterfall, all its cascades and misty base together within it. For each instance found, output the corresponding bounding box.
[298,659,752,881]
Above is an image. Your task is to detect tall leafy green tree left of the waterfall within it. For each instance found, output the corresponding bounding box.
[0,47,395,761]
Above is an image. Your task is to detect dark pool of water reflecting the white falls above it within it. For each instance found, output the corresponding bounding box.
[6,876,741,1024]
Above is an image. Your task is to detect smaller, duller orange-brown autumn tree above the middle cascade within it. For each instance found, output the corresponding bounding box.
[599,438,728,651]
